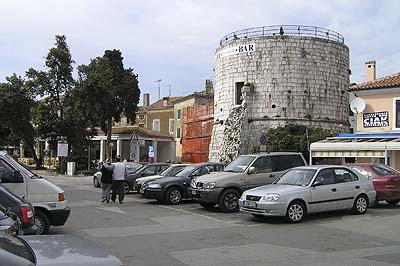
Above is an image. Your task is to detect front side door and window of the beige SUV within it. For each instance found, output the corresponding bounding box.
[244,156,275,190]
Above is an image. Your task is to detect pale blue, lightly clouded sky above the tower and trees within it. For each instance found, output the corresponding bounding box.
[0,0,400,103]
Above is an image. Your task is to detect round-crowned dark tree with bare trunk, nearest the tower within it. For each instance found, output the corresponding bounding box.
[73,49,140,157]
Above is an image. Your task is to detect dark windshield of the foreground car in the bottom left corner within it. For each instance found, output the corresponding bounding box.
[0,234,35,263]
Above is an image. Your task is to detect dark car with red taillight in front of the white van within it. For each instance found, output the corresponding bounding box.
[0,185,37,234]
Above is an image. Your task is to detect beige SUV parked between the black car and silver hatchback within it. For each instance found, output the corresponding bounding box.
[191,152,306,212]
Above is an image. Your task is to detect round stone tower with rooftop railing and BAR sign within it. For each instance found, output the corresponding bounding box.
[209,25,349,161]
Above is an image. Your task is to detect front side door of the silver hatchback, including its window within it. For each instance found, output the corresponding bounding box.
[308,168,339,212]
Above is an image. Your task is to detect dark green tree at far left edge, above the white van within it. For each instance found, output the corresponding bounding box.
[0,74,38,163]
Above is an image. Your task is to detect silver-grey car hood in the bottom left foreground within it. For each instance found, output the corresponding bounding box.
[21,235,122,266]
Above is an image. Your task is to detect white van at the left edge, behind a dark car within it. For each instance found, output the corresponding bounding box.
[0,151,71,234]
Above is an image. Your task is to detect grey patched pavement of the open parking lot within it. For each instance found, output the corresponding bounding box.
[49,177,400,266]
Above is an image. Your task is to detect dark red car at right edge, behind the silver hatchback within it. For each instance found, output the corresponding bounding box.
[348,163,400,205]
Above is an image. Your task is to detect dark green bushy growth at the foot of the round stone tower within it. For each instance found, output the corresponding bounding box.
[266,124,332,158]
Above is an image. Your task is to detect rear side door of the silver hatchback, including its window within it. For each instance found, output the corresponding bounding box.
[334,168,361,209]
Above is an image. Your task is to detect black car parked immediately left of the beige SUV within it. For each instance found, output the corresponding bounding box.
[143,162,225,204]
